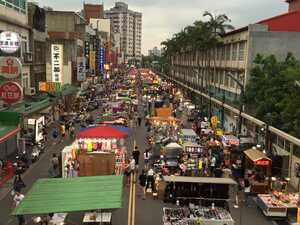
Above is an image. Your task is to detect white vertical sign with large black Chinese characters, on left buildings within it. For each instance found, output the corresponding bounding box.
[51,44,64,82]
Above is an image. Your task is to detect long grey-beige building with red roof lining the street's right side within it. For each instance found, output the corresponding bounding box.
[166,0,300,188]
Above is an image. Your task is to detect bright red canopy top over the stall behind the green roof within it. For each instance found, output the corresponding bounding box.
[76,126,128,139]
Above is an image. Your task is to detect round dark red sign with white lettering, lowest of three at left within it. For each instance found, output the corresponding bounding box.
[0,81,23,104]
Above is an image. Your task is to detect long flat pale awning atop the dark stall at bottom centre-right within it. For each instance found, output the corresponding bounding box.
[163,176,237,185]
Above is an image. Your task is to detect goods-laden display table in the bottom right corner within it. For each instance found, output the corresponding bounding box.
[257,194,298,217]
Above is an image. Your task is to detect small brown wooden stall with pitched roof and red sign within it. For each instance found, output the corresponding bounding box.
[244,149,272,194]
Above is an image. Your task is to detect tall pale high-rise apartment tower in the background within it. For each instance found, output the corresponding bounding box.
[104,2,142,62]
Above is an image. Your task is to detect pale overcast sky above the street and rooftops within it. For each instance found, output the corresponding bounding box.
[38,0,287,54]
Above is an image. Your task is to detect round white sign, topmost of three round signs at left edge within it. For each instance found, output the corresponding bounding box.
[0,31,21,54]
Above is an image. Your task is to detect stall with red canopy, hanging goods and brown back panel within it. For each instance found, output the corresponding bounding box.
[74,126,130,176]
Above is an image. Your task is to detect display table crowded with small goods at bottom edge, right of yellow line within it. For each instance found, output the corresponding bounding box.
[163,207,234,225]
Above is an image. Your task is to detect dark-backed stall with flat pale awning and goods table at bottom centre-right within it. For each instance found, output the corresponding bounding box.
[159,176,237,225]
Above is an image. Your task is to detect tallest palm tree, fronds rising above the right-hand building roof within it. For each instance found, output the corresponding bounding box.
[203,11,234,96]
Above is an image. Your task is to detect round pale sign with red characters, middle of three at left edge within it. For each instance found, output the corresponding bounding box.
[0,57,22,79]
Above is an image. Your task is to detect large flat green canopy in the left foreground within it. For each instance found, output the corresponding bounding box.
[13,176,123,215]
